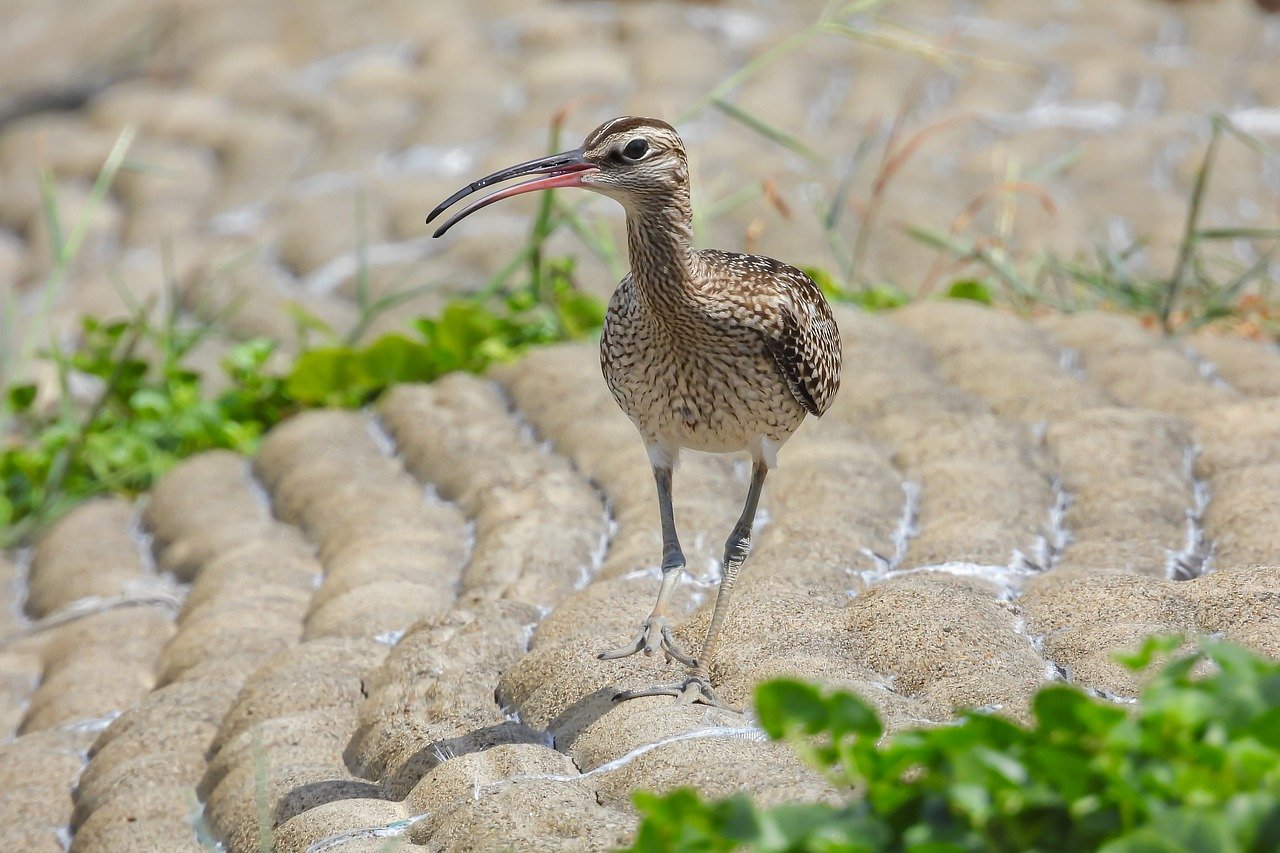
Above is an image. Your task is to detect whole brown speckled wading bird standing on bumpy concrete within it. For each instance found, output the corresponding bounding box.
[426,115,841,707]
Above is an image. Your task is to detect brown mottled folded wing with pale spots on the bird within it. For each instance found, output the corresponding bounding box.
[701,250,840,416]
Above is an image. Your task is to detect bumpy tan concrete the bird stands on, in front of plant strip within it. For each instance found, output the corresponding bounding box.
[0,302,1280,852]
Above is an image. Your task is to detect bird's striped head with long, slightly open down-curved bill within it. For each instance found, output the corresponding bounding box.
[426,115,689,237]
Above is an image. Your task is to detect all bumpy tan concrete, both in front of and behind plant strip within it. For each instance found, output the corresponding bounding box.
[0,0,1280,853]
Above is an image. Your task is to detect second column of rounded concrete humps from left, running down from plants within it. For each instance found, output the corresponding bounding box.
[61,452,317,850]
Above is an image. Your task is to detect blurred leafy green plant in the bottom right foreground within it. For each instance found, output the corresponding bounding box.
[631,638,1280,853]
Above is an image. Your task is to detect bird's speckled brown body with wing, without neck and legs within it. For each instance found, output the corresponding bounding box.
[600,250,840,461]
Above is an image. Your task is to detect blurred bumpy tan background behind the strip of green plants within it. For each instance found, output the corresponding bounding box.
[0,0,1280,371]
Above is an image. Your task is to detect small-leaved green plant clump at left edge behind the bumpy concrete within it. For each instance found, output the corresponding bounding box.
[0,309,294,546]
